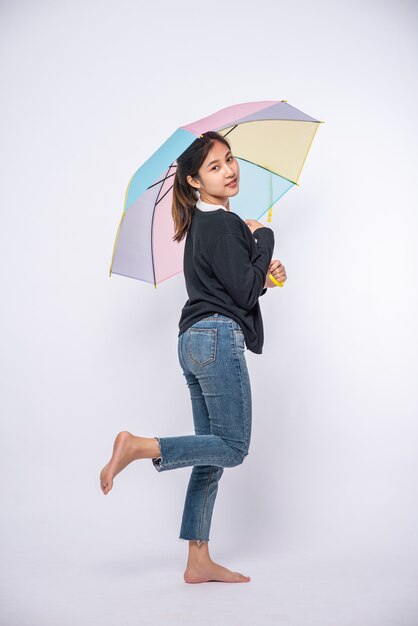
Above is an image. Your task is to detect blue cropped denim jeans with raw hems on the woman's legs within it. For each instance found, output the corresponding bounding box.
[152,313,251,544]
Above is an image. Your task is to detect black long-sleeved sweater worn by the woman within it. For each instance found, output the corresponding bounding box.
[179,206,274,354]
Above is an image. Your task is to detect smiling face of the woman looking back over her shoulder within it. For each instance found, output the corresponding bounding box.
[187,141,239,207]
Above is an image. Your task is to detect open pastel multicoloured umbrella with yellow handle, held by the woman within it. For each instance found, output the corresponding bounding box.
[109,100,323,287]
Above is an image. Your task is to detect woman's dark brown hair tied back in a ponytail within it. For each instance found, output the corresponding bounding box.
[171,130,231,243]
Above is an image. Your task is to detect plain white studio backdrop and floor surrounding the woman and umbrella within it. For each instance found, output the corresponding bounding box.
[0,0,418,626]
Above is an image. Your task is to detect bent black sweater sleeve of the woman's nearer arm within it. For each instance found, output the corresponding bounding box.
[211,227,274,311]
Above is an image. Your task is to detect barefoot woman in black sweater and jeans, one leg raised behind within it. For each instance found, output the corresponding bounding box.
[100,131,286,583]
